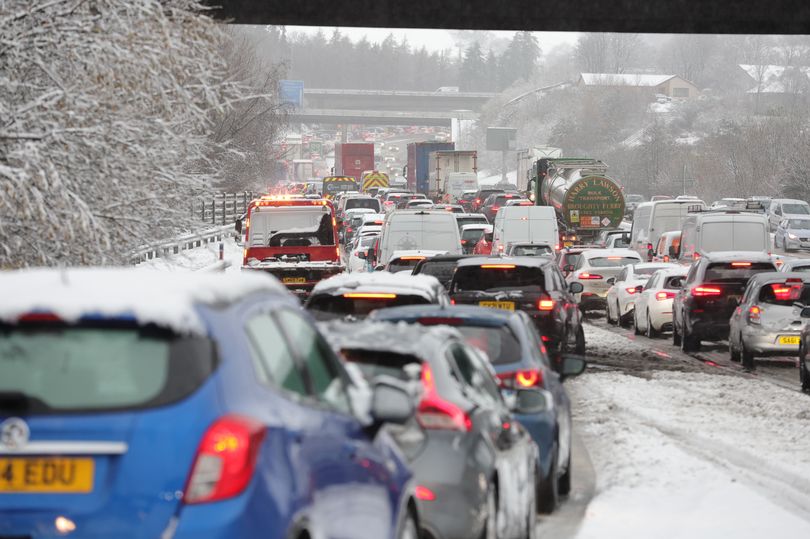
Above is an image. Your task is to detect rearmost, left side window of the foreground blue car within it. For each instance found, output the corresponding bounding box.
[245,314,307,395]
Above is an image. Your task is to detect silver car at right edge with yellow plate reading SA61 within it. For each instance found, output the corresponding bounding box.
[728,272,810,370]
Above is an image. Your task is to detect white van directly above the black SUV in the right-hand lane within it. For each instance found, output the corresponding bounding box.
[678,211,771,263]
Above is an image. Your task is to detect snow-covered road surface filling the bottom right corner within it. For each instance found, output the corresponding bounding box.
[569,372,810,539]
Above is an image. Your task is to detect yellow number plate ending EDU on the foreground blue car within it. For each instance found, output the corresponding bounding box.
[0,458,95,494]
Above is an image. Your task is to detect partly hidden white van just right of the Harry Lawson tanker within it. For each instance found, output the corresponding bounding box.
[630,199,706,262]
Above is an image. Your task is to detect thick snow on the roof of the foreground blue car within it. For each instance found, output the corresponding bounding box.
[0,268,292,335]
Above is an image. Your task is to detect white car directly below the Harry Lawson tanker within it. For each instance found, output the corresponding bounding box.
[563,249,642,311]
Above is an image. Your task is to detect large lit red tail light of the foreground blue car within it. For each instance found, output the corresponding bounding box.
[183,416,267,504]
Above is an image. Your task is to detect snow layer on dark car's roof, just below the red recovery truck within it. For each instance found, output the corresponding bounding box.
[312,271,444,301]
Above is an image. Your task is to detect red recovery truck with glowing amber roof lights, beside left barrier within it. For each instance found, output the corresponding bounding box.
[242,196,345,296]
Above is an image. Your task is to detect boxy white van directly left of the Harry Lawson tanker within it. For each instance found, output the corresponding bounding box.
[492,206,560,254]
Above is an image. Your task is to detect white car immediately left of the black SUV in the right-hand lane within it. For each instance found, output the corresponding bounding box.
[633,265,689,339]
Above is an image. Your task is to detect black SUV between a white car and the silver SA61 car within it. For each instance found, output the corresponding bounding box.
[672,253,776,352]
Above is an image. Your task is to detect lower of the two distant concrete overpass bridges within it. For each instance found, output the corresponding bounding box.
[287,108,479,128]
